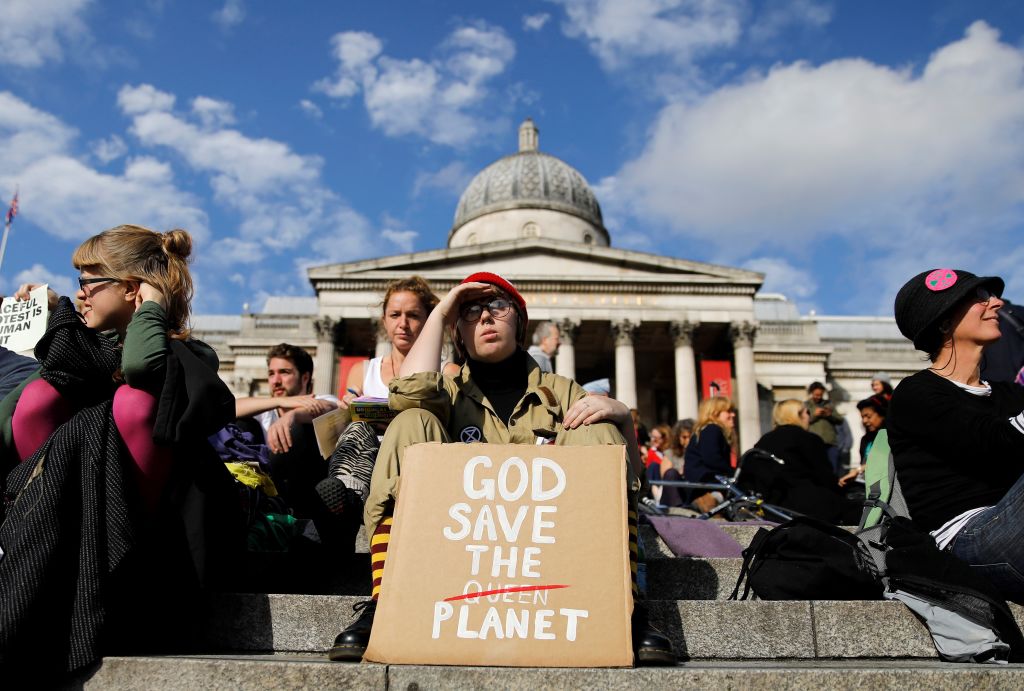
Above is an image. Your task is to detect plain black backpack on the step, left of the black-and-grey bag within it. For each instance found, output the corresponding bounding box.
[729,516,883,600]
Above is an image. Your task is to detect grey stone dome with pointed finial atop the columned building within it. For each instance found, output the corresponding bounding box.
[449,118,608,247]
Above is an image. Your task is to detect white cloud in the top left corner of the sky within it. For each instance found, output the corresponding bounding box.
[0,0,91,68]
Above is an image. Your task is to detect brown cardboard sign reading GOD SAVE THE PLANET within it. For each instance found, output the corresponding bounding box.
[365,443,633,667]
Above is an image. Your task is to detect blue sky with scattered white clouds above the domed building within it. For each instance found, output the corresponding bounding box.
[0,0,1024,314]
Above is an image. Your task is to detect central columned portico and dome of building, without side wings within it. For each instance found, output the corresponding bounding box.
[309,120,778,443]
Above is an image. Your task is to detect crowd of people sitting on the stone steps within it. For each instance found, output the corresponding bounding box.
[0,225,1024,671]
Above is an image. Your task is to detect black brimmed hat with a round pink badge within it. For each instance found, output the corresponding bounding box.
[895,268,1005,351]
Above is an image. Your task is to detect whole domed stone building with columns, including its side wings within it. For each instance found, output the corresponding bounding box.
[196,119,920,449]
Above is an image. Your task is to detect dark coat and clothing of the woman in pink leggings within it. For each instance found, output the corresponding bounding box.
[0,298,244,679]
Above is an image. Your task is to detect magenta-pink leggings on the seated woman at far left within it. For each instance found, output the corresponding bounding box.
[11,379,171,511]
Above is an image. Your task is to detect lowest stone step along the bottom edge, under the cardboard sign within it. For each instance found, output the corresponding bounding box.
[79,655,1024,691]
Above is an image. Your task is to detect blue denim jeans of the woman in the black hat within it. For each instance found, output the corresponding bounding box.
[949,475,1024,604]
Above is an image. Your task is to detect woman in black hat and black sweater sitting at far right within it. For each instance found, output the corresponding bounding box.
[886,269,1024,602]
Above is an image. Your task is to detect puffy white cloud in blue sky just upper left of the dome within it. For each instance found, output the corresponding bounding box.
[313,23,515,145]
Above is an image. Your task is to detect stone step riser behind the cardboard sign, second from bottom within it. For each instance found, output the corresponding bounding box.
[193,594,1024,659]
